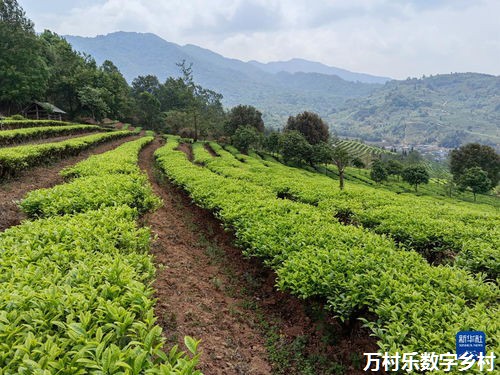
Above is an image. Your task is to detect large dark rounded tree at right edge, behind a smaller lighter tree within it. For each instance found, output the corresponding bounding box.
[450,143,500,188]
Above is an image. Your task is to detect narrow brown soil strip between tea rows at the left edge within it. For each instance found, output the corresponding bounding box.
[0,135,137,231]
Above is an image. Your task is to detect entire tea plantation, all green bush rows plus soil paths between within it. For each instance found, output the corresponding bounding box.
[0,123,500,374]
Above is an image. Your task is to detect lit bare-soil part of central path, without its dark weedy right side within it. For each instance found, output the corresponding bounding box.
[139,140,271,374]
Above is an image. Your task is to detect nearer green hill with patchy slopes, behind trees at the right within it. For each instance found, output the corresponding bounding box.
[329,73,500,147]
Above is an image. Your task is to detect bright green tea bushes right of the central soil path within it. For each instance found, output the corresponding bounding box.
[156,137,500,374]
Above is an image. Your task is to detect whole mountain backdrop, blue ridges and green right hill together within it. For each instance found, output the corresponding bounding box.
[65,32,500,147]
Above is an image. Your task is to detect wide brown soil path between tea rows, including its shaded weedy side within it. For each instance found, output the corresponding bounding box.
[139,140,377,375]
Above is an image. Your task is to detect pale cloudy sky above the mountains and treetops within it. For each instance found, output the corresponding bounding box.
[18,0,500,79]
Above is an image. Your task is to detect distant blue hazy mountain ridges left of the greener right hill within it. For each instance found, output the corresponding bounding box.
[66,32,381,125]
